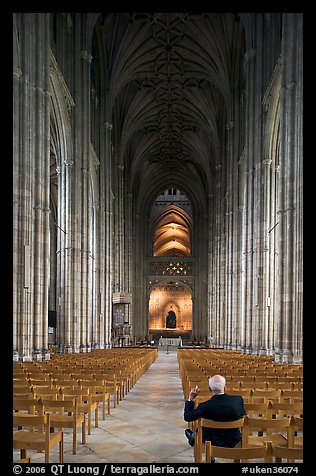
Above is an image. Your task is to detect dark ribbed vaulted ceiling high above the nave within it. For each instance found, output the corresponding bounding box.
[92,13,241,206]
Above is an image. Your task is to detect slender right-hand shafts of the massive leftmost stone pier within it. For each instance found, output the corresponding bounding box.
[33,14,50,360]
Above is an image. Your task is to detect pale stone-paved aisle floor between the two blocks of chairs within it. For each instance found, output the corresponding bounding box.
[14,351,193,463]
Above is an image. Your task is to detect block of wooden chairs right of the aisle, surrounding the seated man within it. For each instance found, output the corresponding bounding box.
[178,349,303,462]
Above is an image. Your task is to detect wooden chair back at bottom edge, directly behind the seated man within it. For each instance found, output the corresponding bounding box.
[205,441,267,463]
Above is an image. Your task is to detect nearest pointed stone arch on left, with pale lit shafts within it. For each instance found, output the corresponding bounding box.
[49,51,74,349]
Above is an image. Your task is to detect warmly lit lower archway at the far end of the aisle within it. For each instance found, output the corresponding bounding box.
[148,282,192,343]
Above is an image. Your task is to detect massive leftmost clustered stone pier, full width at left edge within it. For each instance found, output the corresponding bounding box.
[13,13,49,360]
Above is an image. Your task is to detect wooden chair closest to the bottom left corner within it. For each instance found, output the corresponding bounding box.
[13,411,64,463]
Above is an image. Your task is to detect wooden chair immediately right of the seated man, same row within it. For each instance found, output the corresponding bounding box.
[242,415,291,448]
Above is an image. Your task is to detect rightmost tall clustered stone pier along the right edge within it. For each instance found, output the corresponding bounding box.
[277,13,303,363]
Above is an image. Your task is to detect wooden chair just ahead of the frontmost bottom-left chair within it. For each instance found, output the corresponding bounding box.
[39,398,86,455]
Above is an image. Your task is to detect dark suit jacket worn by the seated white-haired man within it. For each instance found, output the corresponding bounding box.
[184,393,246,448]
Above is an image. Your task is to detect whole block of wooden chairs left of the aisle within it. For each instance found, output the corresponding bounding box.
[13,349,157,463]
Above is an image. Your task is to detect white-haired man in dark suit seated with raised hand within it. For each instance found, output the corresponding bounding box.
[184,375,246,462]
